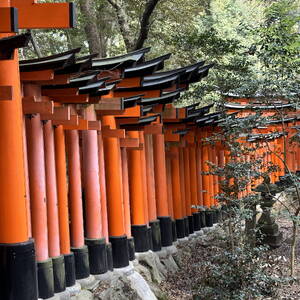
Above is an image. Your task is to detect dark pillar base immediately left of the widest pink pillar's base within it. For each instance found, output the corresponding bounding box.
[72,246,90,279]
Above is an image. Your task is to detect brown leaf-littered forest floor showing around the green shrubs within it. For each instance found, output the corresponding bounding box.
[160,218,300,300]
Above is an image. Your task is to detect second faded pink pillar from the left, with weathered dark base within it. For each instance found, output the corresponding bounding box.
[44,121,66,293]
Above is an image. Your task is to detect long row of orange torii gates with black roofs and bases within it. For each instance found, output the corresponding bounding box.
[0,0,300,300]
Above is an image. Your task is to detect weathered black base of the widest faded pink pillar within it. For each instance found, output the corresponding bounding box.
[85,238,108,275]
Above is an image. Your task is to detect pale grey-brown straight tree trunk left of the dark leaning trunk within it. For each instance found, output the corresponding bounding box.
[79,0,103,56]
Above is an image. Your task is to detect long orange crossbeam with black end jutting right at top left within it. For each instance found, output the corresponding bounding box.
[11,0,75,29]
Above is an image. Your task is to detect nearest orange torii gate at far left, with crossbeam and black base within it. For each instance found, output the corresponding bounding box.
[0,0,75,300]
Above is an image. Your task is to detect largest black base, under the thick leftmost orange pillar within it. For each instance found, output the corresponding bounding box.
[0,240,38,300]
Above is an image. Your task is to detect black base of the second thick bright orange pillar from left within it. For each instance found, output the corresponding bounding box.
[109,235,129,268]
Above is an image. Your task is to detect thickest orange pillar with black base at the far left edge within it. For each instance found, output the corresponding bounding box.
[0,31,38,300]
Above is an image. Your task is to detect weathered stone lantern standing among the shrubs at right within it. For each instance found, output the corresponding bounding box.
[253,176,282,248]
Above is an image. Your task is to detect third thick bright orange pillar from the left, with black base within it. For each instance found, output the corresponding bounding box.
[128,131,152,252]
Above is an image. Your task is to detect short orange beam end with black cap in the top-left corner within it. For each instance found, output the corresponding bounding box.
[0,7,19,33]
